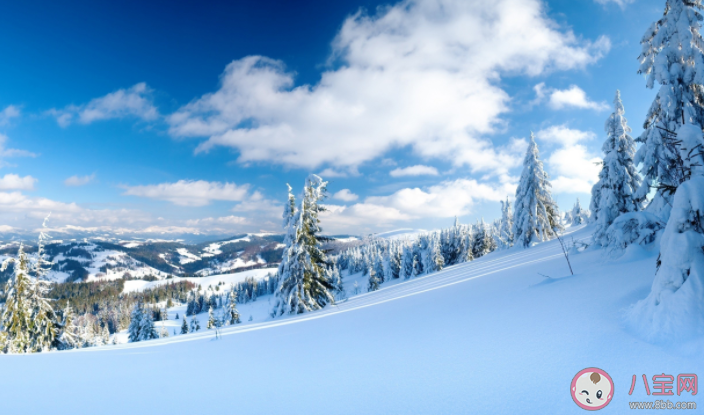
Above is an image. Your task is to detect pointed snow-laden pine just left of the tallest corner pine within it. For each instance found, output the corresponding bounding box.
[588,91,654,245]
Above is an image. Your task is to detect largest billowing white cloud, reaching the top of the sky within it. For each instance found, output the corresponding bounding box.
[168,0,610,176]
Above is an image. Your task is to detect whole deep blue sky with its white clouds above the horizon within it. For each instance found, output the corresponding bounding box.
[0,0,665,234]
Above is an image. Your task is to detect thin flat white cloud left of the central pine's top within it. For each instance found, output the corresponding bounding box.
[123,180,249,206]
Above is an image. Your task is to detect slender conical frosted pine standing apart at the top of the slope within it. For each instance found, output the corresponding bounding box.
[512,133,562,249]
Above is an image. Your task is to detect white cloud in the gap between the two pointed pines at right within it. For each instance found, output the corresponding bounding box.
[535,125,601,194]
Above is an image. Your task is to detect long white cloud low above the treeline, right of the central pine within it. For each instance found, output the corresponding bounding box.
[321,179,516,232]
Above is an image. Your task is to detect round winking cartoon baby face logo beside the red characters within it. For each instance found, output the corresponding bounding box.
[570,367,614,411]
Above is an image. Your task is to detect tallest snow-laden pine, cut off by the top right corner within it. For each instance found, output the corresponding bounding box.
[634,0,704,221]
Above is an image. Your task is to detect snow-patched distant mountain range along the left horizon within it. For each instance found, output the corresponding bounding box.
[0,233,359,282]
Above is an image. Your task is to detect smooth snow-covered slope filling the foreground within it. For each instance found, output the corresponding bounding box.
[0,229,704,415]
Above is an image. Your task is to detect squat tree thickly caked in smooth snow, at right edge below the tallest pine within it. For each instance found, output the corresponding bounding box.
[628,124,704,341]
